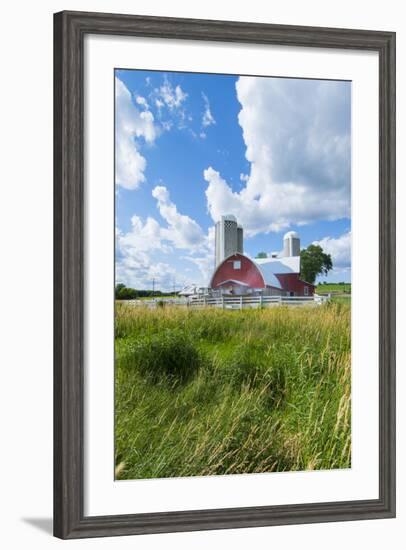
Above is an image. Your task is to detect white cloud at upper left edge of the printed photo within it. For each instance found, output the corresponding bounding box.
[116,78,157,189]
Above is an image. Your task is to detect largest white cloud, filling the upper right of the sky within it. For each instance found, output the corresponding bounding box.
[204,77,351,236]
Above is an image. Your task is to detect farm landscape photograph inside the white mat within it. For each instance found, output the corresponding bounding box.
[111,66,352,480]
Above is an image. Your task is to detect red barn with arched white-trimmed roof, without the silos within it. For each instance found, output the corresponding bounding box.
[210,252,315,296]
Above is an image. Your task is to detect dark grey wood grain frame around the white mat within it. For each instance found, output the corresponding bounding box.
[54,12,395,539]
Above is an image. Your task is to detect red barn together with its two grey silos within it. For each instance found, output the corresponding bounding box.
[209,216,315,296]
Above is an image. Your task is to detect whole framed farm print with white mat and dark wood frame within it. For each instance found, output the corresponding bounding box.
[54,12,395,538]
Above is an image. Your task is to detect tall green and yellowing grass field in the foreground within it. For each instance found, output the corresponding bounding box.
[115,303,351,479]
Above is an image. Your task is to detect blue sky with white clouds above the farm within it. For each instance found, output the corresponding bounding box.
[115,70,351,290]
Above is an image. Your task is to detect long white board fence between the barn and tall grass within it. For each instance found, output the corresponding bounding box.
[122,294,329,309]
